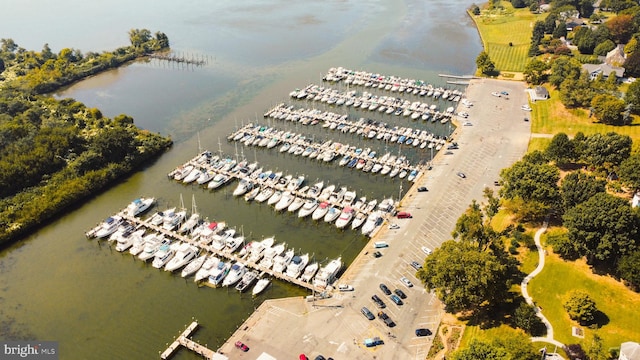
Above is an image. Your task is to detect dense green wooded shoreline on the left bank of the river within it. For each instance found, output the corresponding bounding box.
[0,29,172,245]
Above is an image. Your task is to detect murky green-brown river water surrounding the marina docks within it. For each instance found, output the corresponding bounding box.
[0,0,481,359]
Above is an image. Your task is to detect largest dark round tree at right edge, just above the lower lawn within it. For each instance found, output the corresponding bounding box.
[562,193,639,264]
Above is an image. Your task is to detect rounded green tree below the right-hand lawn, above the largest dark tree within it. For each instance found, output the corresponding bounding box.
[574,132,632,168]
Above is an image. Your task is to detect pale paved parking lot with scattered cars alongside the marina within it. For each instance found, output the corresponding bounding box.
[221,79,530,360]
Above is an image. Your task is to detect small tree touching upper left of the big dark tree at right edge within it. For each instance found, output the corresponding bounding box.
[560,171,606,211]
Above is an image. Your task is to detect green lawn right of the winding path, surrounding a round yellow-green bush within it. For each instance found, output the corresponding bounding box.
[529,245,640,349]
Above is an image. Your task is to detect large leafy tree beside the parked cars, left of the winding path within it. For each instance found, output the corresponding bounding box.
[418,240,510,312]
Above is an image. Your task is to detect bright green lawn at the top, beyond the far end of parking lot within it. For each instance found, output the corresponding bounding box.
[470,1,546,72]
